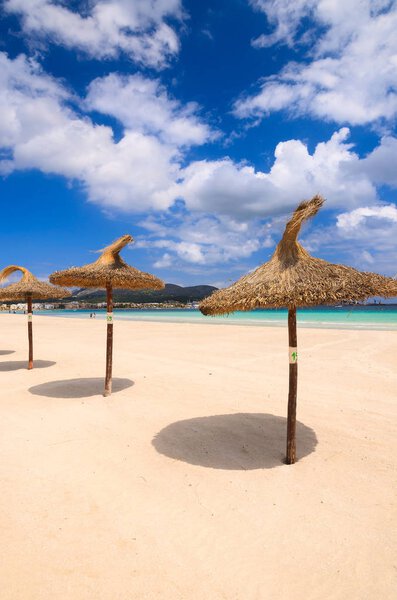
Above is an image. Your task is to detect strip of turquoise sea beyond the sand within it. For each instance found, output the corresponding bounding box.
[17,304,397,331]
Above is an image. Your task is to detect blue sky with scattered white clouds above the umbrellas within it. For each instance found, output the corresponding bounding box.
[0,0,397,286]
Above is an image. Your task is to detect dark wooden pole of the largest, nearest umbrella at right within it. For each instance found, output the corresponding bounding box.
[286,307,298,465]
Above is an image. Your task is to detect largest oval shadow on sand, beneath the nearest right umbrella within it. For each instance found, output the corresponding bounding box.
[152,413,317,471]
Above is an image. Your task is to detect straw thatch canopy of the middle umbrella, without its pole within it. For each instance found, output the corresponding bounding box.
[50,235,164,290]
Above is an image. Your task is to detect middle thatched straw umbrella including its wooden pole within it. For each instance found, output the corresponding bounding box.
[50,235,164,396]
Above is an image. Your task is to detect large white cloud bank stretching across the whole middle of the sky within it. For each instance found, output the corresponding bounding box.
[0,53,395,219]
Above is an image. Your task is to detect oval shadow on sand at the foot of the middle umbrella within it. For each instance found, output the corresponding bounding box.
[29,377,134,398]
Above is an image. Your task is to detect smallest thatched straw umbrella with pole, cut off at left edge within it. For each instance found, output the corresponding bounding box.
[0,265,70,369]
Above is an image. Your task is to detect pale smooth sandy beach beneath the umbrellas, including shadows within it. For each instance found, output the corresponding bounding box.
[0,315,397,600]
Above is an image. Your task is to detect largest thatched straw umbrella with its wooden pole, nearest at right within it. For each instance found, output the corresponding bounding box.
[200,196,397,464]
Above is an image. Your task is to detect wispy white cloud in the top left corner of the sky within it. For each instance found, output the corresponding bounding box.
[4,0,182,69]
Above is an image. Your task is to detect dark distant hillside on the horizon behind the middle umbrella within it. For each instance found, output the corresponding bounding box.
[67,283,217,303]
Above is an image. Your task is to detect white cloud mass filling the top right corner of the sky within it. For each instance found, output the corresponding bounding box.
[234,0,397,125]
